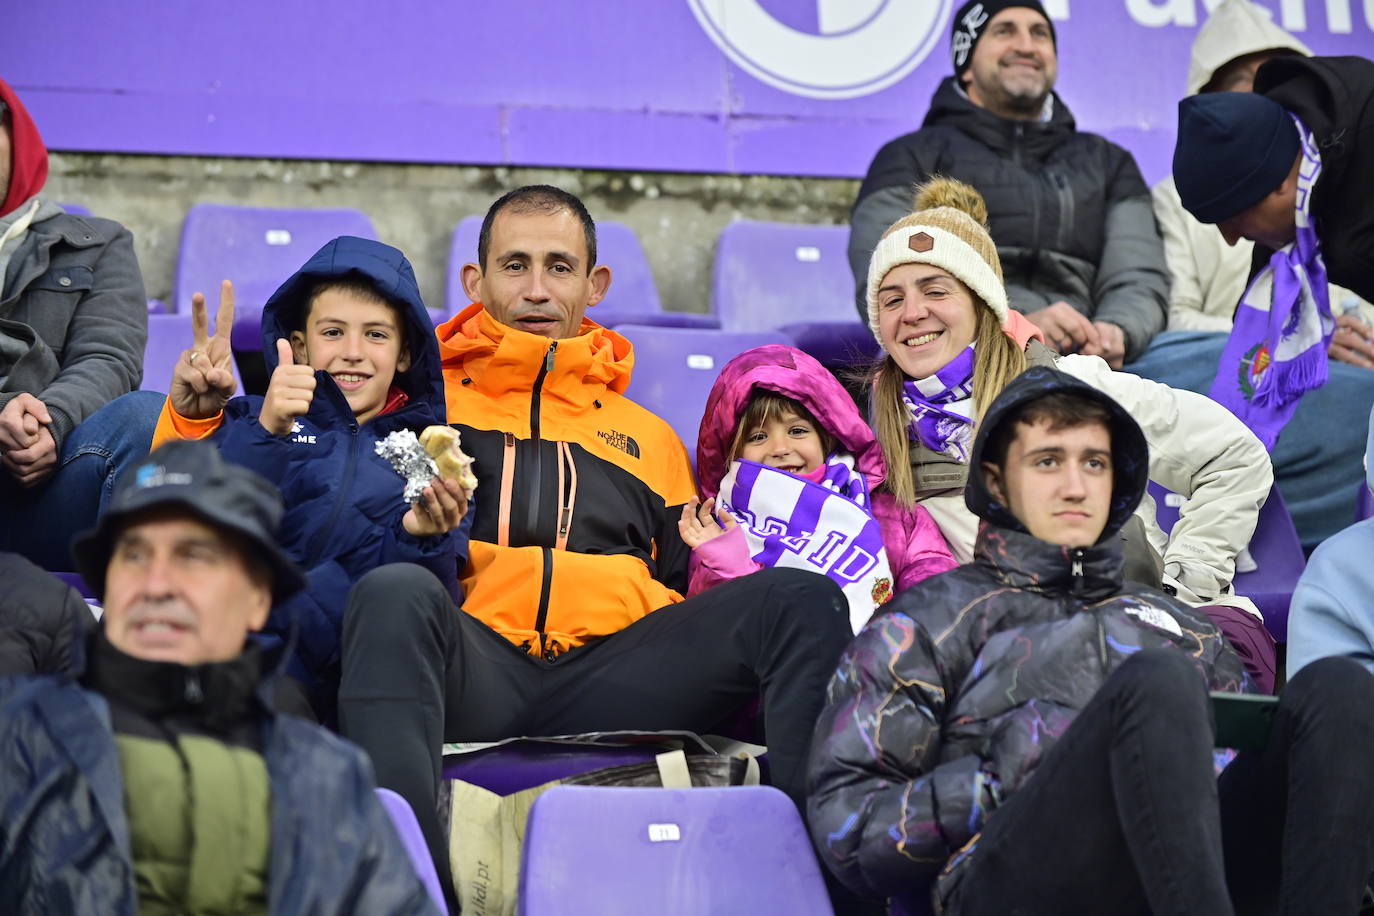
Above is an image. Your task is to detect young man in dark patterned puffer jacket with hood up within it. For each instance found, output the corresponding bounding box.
[808,368,1374,916]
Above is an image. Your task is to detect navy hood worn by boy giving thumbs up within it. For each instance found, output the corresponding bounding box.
[262,235,448,417]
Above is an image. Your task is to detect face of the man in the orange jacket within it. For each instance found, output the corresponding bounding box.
[463,209,610,339]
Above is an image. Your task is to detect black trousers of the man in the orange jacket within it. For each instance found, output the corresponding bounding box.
[339,564,852,911]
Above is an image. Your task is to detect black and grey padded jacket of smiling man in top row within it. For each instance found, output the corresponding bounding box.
[849,77,1169,361]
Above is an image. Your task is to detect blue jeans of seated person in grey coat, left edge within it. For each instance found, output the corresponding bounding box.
[0,391,166,570]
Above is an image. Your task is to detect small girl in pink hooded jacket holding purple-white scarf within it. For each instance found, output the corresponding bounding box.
[679,345,955,632]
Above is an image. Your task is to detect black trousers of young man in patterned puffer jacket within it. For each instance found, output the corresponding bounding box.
[947,650,1374,916]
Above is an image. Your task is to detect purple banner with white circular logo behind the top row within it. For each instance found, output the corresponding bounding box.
[0,0,1374,181]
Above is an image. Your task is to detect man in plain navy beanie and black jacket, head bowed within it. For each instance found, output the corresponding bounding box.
[1173,56,1374,306]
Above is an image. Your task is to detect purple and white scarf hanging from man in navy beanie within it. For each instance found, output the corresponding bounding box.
[1209,115,1336,449]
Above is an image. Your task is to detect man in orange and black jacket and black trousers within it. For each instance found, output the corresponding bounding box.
[339,185,851,911]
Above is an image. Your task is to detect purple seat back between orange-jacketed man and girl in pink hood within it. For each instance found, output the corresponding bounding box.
[616,324,791,466]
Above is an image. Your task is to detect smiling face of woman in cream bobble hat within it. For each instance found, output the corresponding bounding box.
[878,264,978,379]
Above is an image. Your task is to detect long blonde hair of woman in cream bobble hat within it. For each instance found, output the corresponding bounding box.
[871,290,1026,507]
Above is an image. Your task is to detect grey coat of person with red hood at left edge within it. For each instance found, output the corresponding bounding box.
[0,213,148,449]
